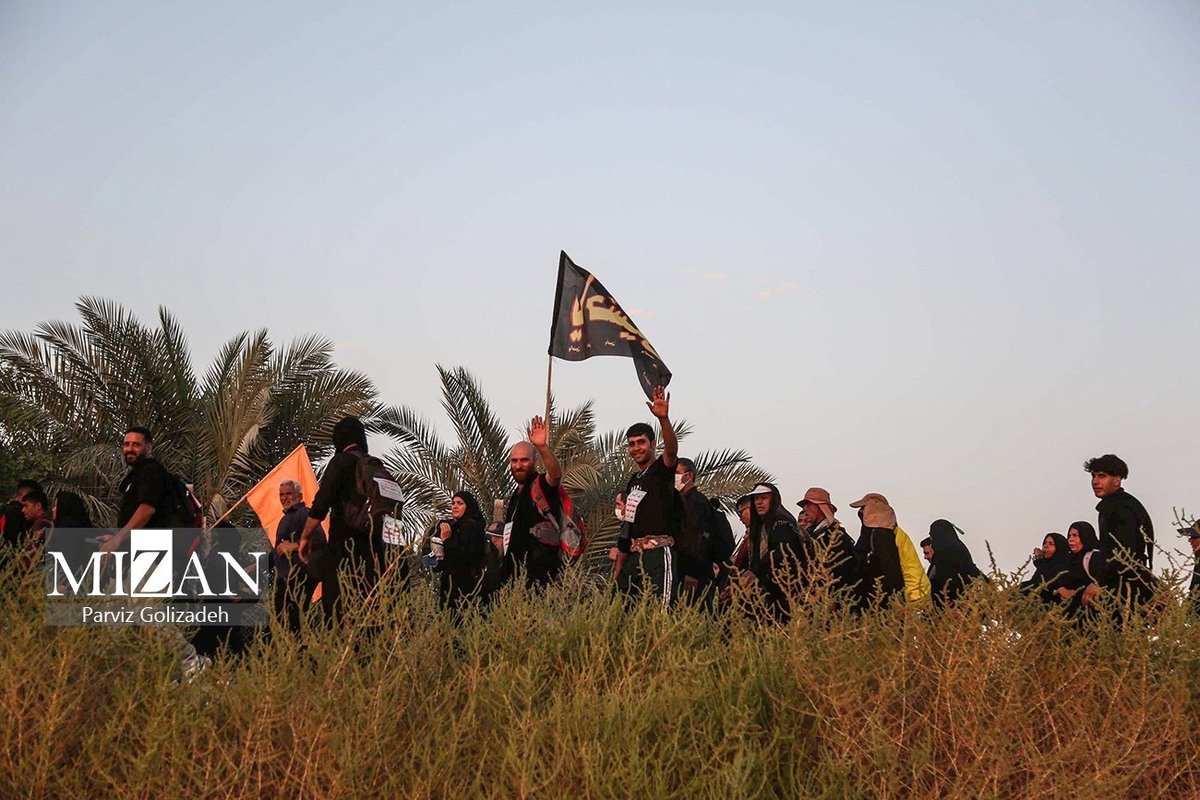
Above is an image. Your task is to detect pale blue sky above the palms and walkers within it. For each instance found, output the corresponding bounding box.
[0,0,1200,569]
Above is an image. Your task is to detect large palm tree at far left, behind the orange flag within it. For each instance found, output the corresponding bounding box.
[0,297,376,522]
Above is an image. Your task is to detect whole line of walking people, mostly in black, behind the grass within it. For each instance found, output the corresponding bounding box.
[0,387,1200,652]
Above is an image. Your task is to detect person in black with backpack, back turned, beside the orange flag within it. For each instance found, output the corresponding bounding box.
[296,416,384,622]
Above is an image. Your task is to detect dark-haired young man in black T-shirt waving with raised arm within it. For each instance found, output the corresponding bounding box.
[617,386,683,607]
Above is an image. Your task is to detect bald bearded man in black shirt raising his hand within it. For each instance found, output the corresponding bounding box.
[502,416,563,587]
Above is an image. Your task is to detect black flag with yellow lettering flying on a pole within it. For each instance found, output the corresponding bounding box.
[550,252,671,399]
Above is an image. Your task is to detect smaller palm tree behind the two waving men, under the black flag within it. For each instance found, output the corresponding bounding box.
[372,365,770,571]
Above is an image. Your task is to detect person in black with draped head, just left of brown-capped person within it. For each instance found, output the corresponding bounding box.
[742,483,811,621]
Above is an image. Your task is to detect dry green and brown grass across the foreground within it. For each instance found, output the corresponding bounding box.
[0,556,1200,799]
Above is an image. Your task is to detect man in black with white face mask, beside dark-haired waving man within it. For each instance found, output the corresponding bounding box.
[674,458,733,607]
